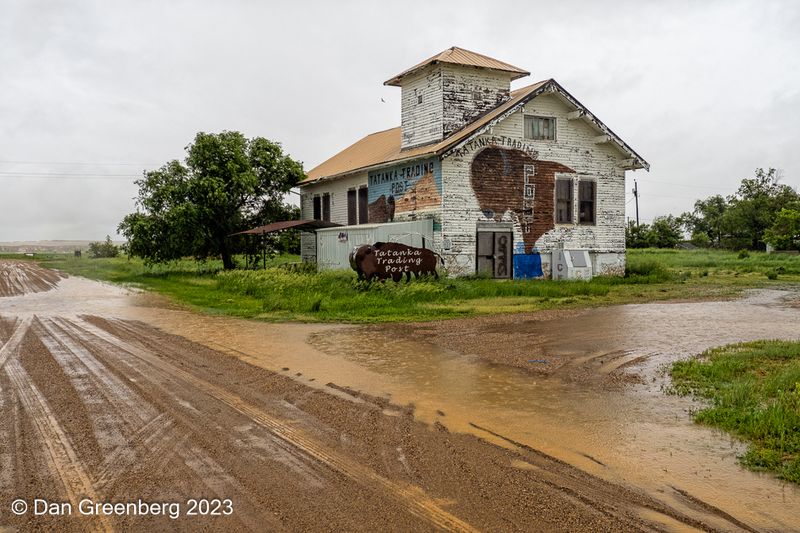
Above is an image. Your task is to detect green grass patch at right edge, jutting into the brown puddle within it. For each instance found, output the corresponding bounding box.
[671,341,800,484]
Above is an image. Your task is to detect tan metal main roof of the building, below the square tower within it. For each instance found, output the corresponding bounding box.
[300,79,650,185]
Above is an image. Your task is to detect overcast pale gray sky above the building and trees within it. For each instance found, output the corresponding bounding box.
[0,0,800,241]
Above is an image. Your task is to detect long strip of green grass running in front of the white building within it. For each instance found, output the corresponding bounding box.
[12,250,800,322]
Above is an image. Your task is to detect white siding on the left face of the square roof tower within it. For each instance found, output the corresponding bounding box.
[400,67,442,148]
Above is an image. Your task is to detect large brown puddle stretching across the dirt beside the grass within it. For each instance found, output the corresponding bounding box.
[0,277,800,531]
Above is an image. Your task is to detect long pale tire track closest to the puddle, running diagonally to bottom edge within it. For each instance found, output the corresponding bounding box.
[72,320,477,531]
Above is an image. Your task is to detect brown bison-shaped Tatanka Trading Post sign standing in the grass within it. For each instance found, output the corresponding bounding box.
[350,242,444,281]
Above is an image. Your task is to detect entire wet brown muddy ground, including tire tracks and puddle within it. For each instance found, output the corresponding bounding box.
[0,265,800,531]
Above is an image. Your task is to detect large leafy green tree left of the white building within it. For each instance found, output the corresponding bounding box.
[119,131,305,269]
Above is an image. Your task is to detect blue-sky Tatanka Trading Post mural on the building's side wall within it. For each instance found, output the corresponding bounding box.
[367,158,442,223]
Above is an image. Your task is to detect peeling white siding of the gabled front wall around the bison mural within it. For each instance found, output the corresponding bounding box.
[442,94,625,274]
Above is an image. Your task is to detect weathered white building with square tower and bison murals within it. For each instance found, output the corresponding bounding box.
[300,47,649,278]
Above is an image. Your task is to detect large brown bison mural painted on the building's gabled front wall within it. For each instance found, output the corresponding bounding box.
[470,145,574,253]
